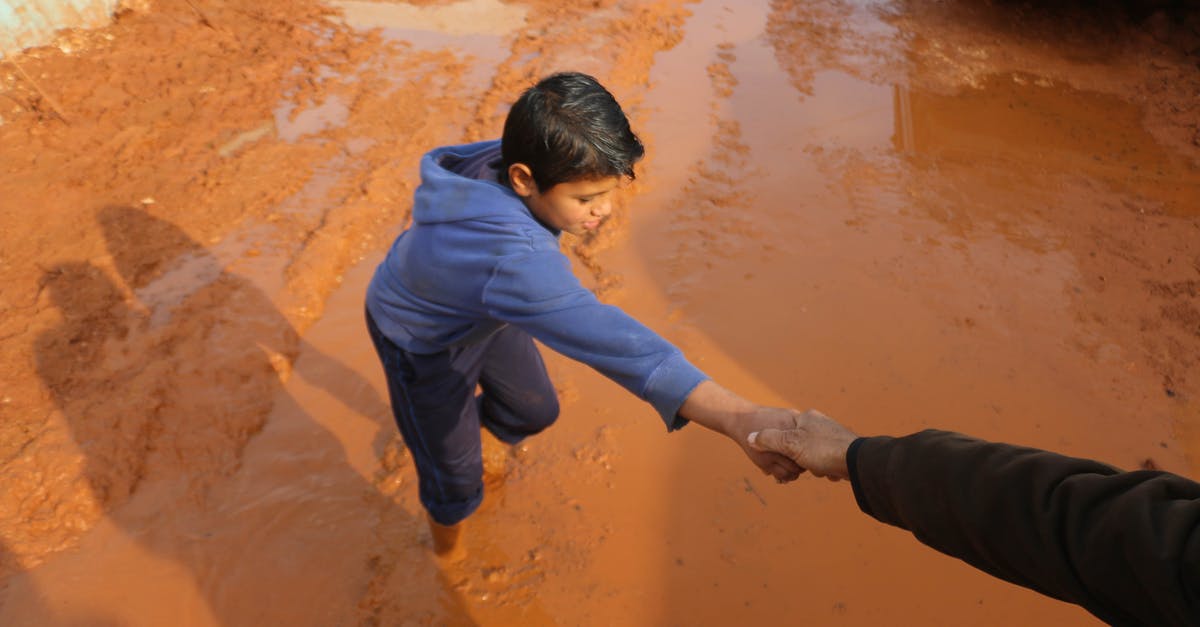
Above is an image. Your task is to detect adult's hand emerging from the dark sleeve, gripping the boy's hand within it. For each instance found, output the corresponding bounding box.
[746,410,858,482]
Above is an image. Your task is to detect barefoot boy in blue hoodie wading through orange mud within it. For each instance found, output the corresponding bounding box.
[366,73,802,557]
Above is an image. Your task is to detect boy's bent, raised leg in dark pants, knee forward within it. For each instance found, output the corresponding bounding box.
[479,324,558,444]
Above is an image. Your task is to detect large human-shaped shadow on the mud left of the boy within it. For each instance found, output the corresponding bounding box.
[18,207,470,625]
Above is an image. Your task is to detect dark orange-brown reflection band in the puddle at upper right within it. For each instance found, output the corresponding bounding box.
[893,73,1200,215]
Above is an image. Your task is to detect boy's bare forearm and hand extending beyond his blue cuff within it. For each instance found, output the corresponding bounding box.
[679,380,804,483]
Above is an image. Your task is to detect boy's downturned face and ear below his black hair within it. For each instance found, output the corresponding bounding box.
[509,163,620,235]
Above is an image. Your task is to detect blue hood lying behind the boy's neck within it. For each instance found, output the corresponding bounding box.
[413,139,530,225]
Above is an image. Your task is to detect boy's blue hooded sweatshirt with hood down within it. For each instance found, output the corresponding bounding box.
[367,141,708,430]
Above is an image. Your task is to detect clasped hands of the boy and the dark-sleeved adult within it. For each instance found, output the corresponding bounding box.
[739,407,858,483]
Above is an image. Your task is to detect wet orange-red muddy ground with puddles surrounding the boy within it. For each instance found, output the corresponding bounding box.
[0,0,1200,626]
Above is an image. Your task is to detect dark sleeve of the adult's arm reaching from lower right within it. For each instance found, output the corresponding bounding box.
[846,430,1200,626]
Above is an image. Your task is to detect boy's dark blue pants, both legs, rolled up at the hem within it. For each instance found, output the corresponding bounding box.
[367,314,558,525]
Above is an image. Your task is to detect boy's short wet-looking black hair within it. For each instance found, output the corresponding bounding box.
[500,72,646,191]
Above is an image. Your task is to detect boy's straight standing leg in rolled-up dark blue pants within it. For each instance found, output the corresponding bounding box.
[367,315,487,531]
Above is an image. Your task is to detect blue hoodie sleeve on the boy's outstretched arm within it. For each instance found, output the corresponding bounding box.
[482,246,708,430]
